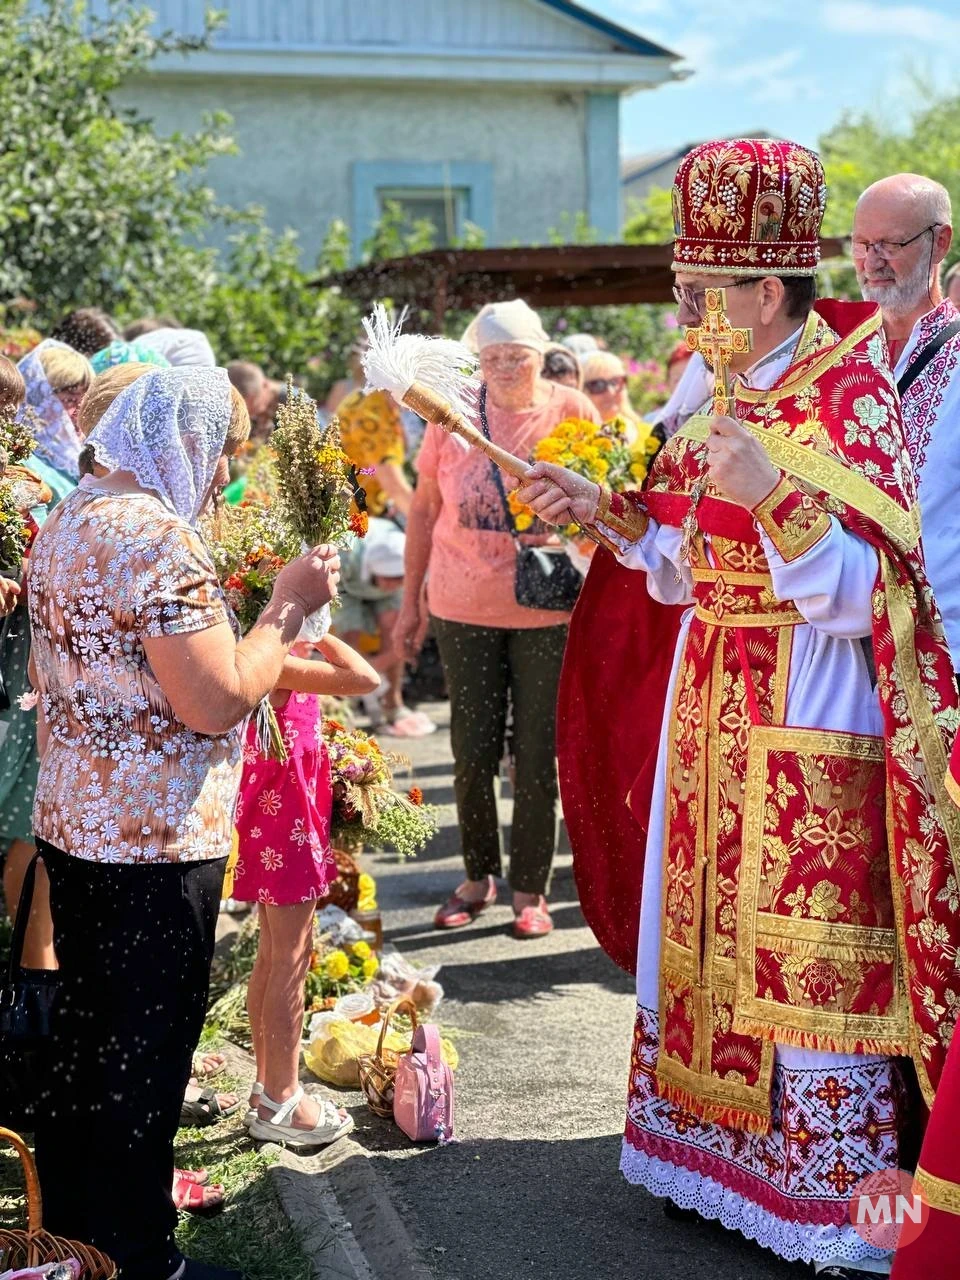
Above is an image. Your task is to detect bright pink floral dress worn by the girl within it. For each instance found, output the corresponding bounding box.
[233,692,337,906]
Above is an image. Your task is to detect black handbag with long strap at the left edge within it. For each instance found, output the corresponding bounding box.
[0,854,59,1130]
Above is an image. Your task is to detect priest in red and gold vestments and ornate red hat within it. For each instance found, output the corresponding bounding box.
[520,140,960,1277]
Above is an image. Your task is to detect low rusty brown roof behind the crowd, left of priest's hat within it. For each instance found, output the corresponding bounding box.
[314,239,844,332]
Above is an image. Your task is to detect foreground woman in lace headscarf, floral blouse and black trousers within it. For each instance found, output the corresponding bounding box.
[28,369,338,1280]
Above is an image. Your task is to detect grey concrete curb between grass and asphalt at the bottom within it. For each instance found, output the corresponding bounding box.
[223,1043,435,1280]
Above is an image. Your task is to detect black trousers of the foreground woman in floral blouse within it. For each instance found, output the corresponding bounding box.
[36,841,225,1280]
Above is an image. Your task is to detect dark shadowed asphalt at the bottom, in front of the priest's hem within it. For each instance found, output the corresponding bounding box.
[361,1136,810,1280]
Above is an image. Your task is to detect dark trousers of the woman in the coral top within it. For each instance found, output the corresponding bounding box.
[433,618,567,893]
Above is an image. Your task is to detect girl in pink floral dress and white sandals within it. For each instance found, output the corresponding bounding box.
[233,614,380,1146]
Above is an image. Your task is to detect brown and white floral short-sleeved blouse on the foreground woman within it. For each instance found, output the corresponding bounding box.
[29,484,242,863]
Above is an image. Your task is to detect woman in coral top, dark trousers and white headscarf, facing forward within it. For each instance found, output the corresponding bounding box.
[397,300,599,938]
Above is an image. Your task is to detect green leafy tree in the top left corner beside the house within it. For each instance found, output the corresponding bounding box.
[0,0,234,324]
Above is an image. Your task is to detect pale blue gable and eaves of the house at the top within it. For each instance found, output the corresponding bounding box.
[136,0,685,93]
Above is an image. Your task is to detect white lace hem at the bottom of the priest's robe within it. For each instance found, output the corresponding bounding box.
[620,1142,892,1263]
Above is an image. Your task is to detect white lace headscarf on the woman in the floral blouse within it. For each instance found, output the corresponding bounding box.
[87,369,232,525]
